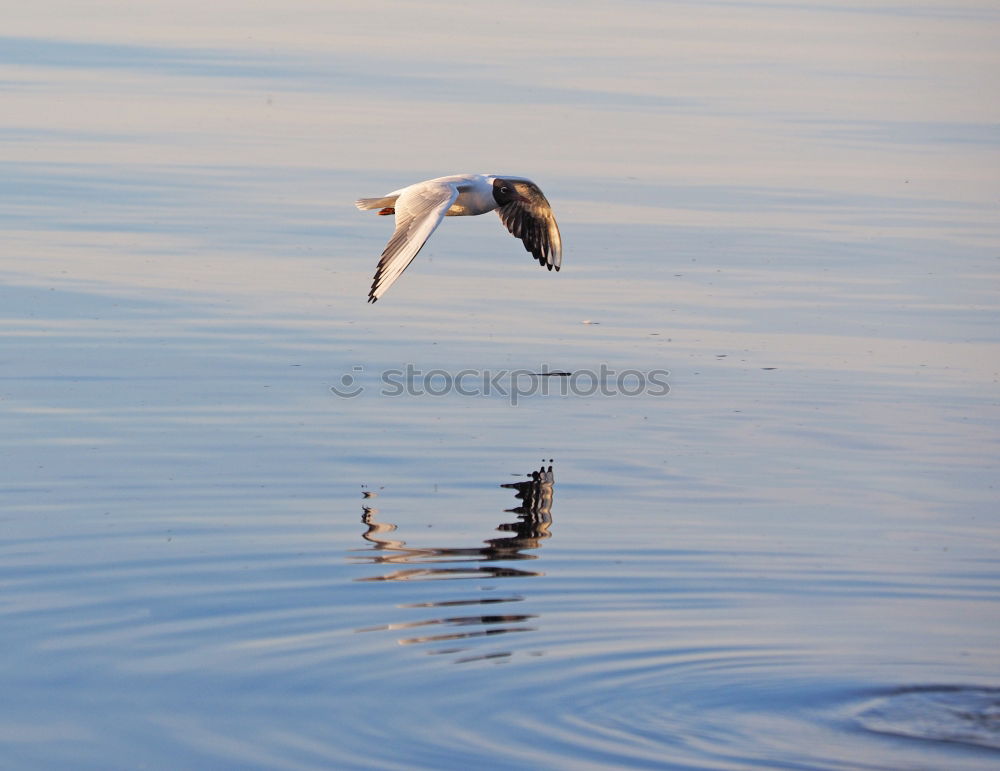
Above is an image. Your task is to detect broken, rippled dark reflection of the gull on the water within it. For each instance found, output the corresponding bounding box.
[356,461,555,661]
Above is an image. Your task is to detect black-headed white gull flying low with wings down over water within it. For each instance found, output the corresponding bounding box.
[355,174,562,303]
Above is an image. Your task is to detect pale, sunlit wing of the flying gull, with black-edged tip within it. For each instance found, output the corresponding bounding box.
[368,182,458,303]
